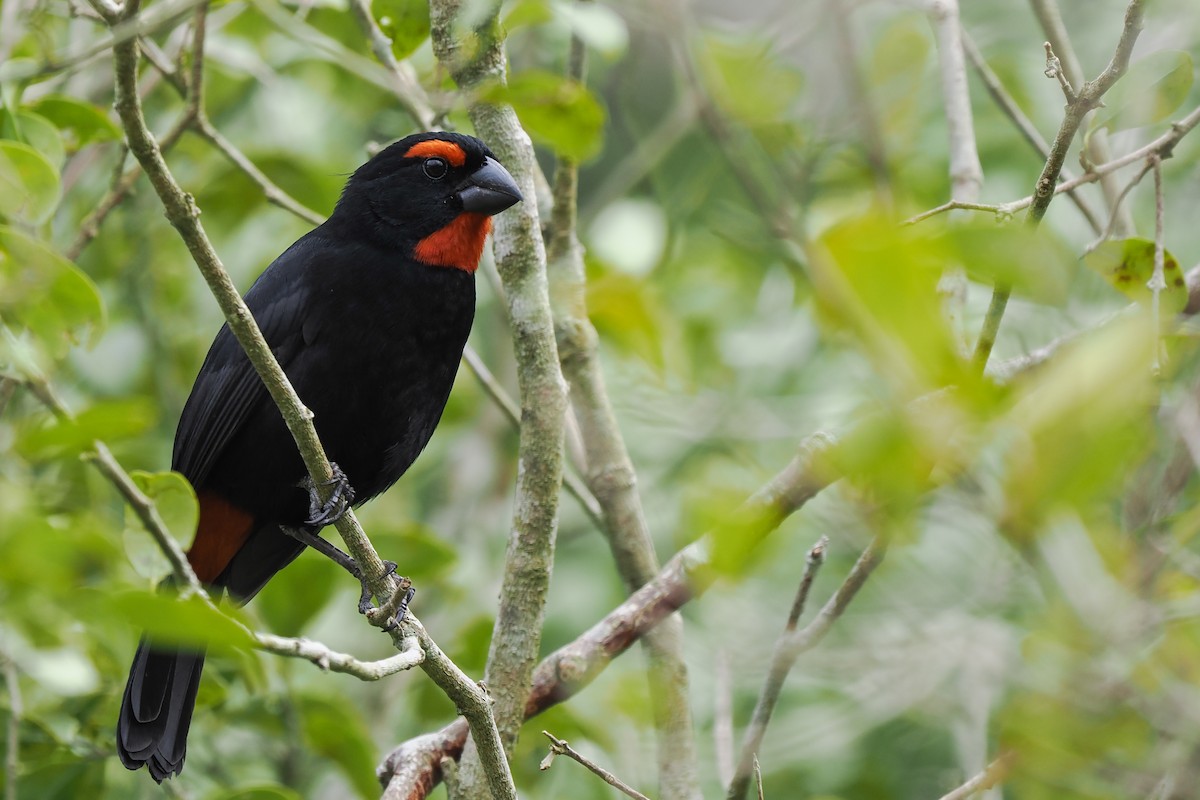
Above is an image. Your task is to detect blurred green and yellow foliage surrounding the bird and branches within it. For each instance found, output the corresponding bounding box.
[0,0,1200,800]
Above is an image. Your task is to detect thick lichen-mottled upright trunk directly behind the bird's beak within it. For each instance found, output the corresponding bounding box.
[430,0,566,798]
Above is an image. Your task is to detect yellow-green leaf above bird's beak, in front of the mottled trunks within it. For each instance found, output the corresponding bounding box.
[480,71,605,161]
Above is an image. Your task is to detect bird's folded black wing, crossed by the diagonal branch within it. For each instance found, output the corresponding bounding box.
[172,234,323,488]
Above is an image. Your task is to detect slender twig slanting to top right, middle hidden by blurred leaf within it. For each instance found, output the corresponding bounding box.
[973,0,1145,372]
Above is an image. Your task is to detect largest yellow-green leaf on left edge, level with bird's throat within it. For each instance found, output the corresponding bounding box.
[0,225,104,354]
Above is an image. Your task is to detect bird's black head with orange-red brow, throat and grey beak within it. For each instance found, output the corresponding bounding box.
[335,131,522,272]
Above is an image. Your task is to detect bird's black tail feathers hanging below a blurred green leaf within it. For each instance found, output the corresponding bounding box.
[116,639,204,783]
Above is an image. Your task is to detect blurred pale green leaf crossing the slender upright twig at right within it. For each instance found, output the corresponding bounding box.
[943,218,1078,305]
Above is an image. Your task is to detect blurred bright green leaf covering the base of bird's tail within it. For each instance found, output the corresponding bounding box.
[99,591,254,651]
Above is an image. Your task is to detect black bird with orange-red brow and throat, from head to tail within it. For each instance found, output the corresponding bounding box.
[116,132,520,781]
